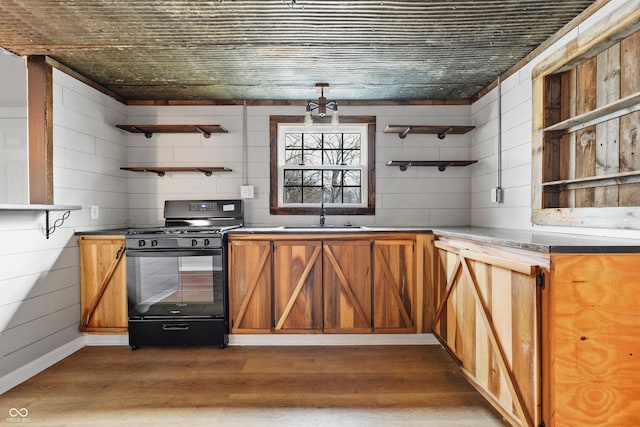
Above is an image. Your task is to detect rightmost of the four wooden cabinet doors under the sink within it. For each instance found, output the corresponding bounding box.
[373,240,416,332]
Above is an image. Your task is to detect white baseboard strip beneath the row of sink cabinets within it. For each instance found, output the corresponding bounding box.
[229,334,440,346]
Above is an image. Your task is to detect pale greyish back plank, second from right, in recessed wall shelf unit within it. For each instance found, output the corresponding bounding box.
[594,43,620,206]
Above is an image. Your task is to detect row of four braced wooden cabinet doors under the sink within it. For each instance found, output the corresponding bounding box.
[229,233,424,333]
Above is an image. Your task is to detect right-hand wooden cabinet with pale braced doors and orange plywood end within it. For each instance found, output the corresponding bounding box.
[433,237,640,426]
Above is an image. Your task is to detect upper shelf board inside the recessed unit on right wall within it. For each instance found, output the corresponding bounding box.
[544,92,640,134]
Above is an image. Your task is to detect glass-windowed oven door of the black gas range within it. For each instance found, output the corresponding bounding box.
[127,248,226,319]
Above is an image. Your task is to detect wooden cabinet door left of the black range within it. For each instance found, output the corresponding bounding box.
[79,236,128,333]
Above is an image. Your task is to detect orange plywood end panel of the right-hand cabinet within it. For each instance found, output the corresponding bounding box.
[545,254,640,426]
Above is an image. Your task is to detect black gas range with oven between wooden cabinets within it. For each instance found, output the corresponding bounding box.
[125,200,244,349]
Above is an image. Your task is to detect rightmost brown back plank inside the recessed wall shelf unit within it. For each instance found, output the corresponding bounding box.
[619,32,640,206]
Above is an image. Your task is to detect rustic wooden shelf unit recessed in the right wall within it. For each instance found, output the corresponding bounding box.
[531,4,640,229]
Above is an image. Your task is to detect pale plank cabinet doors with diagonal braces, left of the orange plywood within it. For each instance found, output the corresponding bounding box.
[433,241,541,426]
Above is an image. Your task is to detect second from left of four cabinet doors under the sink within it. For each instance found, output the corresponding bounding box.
[273,240,322,332]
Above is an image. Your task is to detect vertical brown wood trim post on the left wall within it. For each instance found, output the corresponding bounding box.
[27,55,53,205]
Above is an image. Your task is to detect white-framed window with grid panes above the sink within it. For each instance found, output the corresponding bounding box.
[272,115,375,214]
